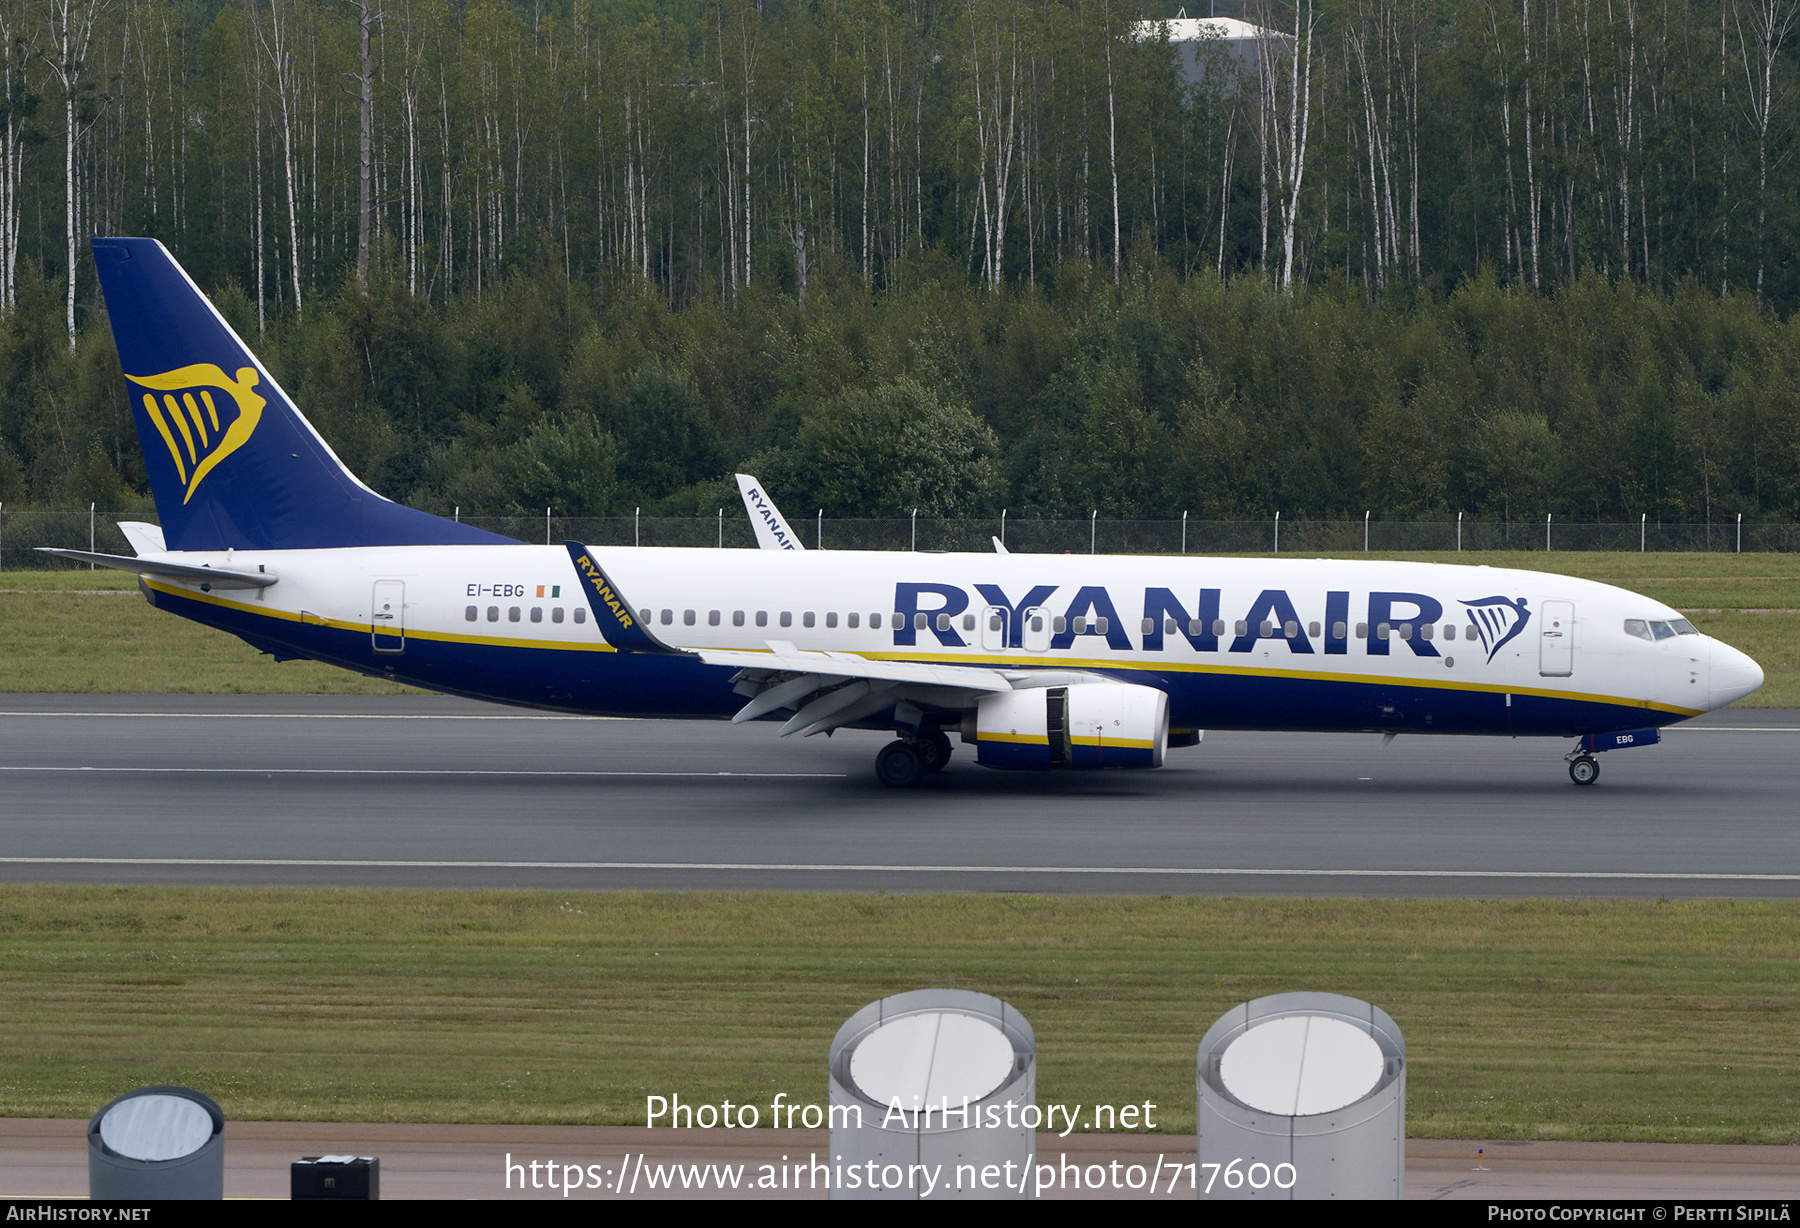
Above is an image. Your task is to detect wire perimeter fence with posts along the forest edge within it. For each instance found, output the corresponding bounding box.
[0,506,1800,571]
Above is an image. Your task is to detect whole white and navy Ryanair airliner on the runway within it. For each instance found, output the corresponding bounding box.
[56,239,1762,787]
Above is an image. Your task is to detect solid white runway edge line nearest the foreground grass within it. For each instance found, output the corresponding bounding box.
[0,857,1800,882]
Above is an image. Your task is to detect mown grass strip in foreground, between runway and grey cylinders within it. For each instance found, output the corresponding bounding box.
[0,886,1800,1143]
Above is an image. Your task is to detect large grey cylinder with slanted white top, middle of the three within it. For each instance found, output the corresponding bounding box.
[828,989,1039,1199]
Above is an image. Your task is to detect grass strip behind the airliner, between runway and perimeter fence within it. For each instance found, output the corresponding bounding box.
[0,551,1800,708]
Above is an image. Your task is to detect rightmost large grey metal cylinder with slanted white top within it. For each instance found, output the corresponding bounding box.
[1195,994,1406,1199]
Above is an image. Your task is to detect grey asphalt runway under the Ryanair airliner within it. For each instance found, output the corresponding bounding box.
[0,695,1800,898]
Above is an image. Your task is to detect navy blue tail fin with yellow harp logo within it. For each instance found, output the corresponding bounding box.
[94,239,511,551]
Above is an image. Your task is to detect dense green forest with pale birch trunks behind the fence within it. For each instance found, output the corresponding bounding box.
[0,0,1800,519]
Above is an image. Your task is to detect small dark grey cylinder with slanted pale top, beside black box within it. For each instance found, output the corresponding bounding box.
[88,1088,225,1201]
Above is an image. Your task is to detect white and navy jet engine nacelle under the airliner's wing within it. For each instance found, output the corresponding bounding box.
[963,682,1168,771]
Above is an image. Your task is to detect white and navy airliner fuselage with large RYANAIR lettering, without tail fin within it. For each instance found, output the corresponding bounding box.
[133,546,1762,735]
